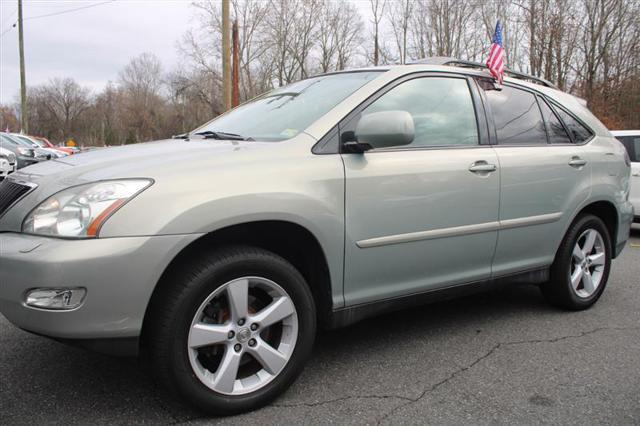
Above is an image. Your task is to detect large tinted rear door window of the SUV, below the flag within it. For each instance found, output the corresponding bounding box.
[485,86,547,145]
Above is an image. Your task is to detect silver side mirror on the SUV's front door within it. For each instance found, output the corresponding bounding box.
[355,111,415,148]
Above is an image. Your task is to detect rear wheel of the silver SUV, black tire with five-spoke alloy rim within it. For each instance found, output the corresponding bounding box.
[540,214,611,311]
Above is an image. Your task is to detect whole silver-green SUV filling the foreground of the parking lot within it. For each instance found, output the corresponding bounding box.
[0,60,633,414]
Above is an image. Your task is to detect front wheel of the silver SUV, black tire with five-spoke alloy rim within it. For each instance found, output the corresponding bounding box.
[143,246,316,415]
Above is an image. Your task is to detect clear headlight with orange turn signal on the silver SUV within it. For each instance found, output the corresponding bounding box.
[22,179,152,238]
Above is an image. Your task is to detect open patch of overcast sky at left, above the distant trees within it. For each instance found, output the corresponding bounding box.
[0,0,194,104]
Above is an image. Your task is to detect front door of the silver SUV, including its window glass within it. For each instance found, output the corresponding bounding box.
[340,74,500,305]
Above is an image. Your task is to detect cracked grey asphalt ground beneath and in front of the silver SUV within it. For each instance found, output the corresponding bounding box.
[0,227,640,424]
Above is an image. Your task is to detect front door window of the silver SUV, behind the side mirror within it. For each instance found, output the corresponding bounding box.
[362,77,478,148]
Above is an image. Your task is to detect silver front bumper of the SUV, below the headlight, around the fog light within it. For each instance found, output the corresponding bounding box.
[0,233,200,340]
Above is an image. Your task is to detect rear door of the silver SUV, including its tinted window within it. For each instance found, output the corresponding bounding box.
[482,84,591,277]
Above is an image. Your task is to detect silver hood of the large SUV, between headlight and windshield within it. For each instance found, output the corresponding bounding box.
[10,139,278,186]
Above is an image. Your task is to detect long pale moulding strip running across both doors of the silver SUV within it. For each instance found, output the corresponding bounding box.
[356,212,562,248]
